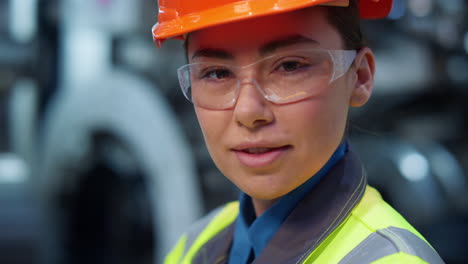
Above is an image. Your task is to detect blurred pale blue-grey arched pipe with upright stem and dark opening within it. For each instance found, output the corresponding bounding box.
[37,0,201,263]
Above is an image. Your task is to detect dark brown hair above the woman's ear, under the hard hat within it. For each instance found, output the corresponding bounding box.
[327,0,367,50]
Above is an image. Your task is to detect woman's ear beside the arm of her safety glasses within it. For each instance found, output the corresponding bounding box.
[349,47,375,107]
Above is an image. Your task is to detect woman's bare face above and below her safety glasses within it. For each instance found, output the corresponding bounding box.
[188,7,370,200]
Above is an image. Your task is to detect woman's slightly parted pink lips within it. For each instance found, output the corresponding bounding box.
[233,145,292,168]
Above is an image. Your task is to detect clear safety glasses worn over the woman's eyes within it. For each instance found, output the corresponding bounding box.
[177,49,356,109]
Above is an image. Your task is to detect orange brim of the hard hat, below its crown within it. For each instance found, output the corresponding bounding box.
[152,0,392,42]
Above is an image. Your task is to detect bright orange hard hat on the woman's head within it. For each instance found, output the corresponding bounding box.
[152,0,392,46]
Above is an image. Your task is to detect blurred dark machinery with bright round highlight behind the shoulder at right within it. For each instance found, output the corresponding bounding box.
[352,136,468,263]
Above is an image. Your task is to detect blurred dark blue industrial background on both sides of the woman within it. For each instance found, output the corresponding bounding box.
[0,0,468,264]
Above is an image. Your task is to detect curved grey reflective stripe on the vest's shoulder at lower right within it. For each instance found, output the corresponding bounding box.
[339,226,444,264]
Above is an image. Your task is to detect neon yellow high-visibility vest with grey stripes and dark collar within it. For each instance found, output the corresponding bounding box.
[165,154,444,264]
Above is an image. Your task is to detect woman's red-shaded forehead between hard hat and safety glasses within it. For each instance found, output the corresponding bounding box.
[188,7,341,55]
